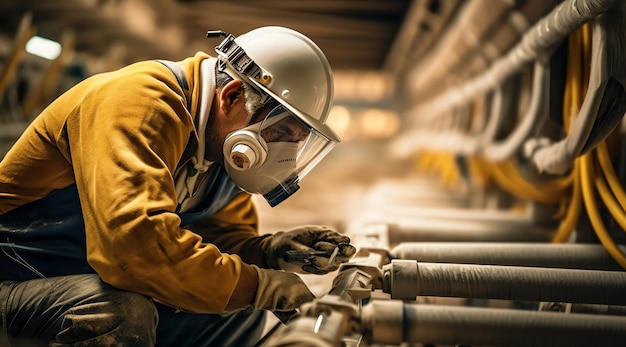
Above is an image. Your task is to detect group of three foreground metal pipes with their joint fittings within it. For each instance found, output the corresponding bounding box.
[260,243,626,347]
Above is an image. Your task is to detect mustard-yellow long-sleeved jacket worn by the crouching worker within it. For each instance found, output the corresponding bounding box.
[0,52,266,313]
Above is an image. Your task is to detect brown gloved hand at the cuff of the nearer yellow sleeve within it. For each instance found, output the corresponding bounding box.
[252,266,315,311]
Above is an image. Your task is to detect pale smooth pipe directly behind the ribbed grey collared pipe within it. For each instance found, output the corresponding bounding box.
[390,242,626,271]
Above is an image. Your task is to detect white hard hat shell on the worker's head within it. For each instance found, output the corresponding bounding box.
[215,26,339,142]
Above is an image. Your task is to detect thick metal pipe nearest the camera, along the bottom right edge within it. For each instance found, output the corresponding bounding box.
[362,300,626,347]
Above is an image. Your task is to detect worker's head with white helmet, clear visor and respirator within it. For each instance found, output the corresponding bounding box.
[210,27,339,206]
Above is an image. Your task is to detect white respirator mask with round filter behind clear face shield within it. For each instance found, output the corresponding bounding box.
[224,105,336,207]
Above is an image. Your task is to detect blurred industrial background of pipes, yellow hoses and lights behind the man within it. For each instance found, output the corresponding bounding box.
[0,0,626,346]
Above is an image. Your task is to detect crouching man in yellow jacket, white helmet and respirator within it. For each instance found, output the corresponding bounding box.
[0,27,355,347]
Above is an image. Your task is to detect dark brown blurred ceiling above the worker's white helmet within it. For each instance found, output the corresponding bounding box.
[0,0,420,70]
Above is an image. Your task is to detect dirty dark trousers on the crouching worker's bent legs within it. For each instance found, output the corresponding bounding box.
[0,274,265,347]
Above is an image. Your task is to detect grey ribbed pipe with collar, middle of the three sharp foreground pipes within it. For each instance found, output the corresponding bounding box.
[383,259,626,305]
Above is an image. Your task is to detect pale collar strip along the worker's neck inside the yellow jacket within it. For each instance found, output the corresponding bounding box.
[176,58,217,204]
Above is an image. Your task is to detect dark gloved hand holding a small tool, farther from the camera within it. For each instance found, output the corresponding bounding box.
[265,225,356,275]
